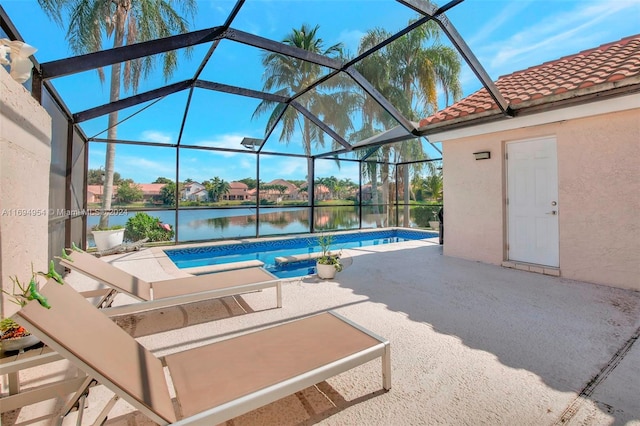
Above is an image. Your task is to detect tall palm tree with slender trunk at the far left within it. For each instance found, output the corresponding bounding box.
[38,0,197,227]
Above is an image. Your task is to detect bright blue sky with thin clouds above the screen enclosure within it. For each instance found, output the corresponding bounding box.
[0,0,640,183]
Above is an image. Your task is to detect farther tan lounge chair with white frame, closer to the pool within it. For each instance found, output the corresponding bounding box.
[60,251,282,316]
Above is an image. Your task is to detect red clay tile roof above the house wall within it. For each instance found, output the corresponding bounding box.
[420,34,640,128]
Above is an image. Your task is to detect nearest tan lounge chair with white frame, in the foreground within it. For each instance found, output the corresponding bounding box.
[16,280,391,425]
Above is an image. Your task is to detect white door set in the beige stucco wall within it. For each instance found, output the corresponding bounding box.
[507,137,560,267]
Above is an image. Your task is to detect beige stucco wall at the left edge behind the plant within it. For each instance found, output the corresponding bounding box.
[0,67,51,316]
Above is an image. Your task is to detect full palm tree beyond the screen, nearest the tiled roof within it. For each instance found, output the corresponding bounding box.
[356,16,462,226]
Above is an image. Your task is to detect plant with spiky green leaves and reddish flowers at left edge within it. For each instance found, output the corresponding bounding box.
[0,260,64,352]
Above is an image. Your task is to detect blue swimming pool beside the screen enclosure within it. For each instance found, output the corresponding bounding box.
[164,229,438,278]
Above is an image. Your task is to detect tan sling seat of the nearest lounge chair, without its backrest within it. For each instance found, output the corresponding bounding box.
[165,313,380,417]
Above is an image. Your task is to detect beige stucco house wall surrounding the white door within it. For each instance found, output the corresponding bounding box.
[443,109,640,290]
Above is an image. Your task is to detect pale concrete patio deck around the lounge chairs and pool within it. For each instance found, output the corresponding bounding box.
[2,241,640,426]
